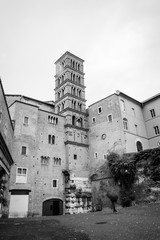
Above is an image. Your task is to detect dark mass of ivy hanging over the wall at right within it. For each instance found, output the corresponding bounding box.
[90,148,160,207]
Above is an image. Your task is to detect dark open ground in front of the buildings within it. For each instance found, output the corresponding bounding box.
[0,203,160,240]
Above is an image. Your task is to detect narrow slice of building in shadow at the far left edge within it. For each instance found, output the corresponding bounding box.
[0,80,13,215]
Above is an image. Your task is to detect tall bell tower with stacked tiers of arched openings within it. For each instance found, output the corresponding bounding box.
[55,51,89,177]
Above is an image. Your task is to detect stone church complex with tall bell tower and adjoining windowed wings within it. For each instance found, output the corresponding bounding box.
[1,52,160,217]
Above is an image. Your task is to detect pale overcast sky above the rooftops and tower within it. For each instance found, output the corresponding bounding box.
[0,0,160,106]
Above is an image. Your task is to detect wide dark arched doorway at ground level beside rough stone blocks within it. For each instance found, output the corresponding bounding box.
[42,198,63,216]
